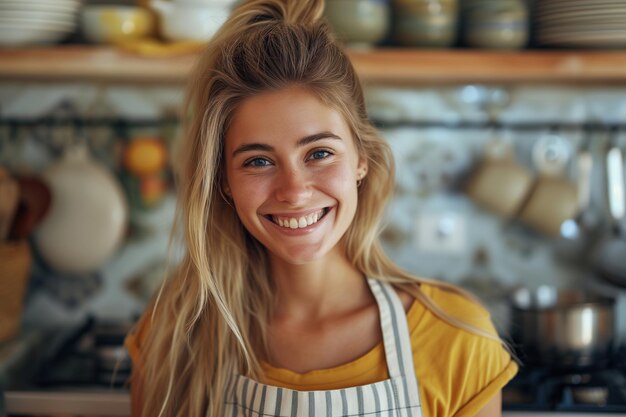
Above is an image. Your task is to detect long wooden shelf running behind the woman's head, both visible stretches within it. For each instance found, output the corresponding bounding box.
[0,45,626,85]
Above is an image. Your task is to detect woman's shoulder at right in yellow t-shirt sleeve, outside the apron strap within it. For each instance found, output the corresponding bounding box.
[407,283,517,416]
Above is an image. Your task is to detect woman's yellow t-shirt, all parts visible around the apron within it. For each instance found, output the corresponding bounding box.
[126,284,518,417]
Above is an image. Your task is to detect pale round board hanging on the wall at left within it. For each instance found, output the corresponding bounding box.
[35,144,128,274]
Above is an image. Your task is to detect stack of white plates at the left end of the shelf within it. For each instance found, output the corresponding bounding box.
[0,0,81,47]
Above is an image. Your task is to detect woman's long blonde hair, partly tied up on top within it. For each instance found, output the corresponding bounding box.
[135,0,502,417]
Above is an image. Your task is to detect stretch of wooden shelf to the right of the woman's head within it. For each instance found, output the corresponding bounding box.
[351,49,626,84]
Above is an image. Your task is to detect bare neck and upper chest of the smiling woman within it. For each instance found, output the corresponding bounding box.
[271,250,373,322]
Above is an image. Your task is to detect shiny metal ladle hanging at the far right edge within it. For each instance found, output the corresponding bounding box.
[594,138,626,287]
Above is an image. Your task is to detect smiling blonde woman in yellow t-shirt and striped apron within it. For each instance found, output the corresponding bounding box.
[126,0,517,417]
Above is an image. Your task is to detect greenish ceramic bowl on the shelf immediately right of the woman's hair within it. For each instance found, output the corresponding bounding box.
[324,0,391,47]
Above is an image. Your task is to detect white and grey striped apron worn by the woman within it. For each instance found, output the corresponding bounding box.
[225,279,422,417]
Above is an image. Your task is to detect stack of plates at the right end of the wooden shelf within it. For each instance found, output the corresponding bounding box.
[537,0,626,48]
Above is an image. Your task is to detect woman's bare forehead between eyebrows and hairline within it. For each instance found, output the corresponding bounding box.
[226,86,352,150]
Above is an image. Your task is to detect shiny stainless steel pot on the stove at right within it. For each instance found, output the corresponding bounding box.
[511,286,617,368]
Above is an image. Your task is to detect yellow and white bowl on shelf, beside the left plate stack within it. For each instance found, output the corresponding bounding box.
[80,6,155,43]
